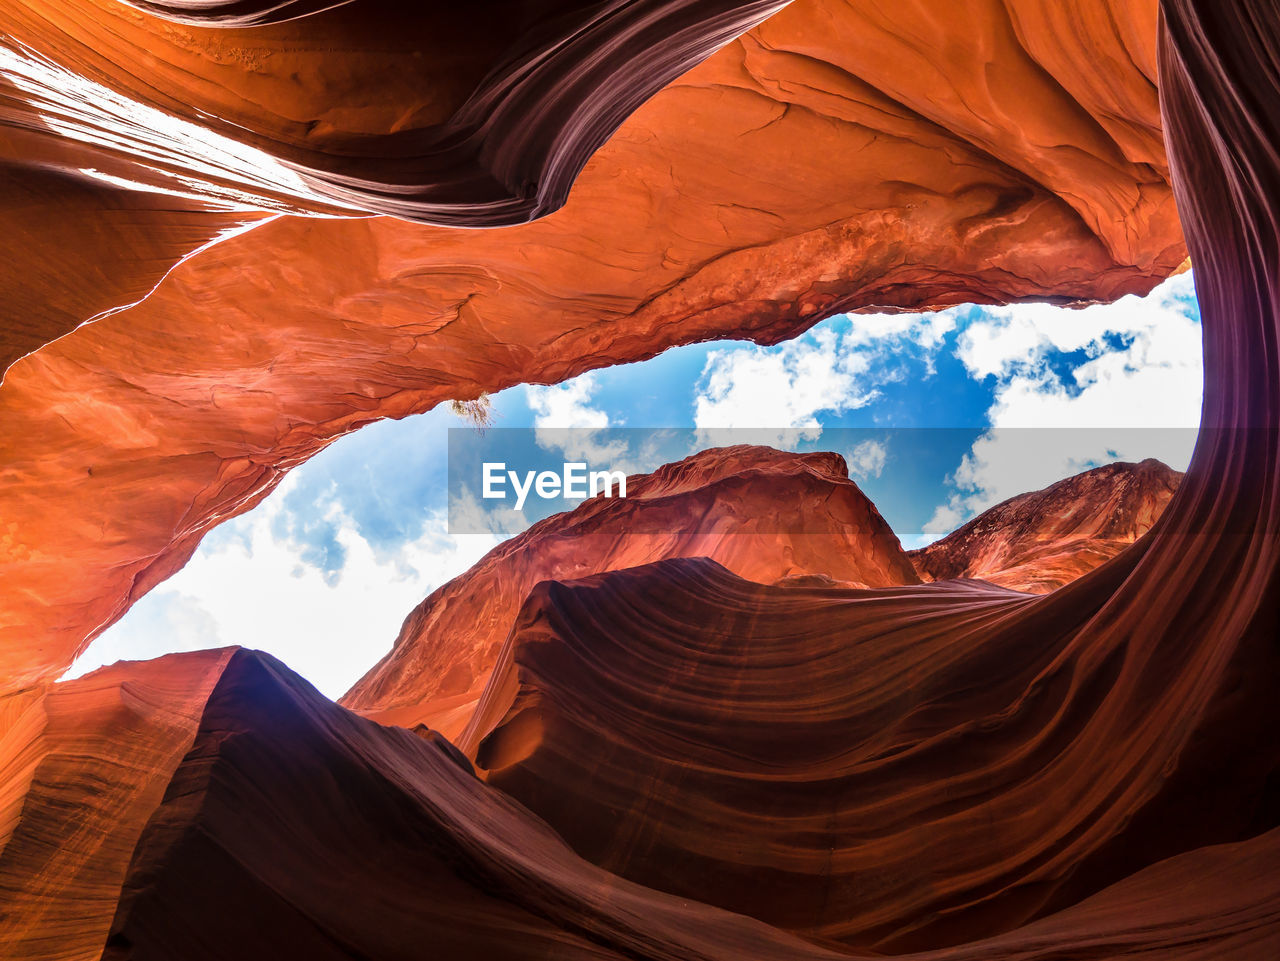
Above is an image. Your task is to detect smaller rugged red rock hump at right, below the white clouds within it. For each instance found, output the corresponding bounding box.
[909,459,1183,594]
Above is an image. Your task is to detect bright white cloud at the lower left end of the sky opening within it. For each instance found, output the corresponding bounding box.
[67,470,499,697]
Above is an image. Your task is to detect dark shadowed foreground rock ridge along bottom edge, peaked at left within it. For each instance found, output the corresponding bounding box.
[10,639,1280,961]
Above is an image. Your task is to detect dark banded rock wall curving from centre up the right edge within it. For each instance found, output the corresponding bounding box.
[453,0,1280,957]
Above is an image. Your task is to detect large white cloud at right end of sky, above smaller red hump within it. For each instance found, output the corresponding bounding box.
[925,274,1203,539]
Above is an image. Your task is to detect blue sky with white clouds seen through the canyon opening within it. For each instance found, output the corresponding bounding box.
[70,274,1201,696]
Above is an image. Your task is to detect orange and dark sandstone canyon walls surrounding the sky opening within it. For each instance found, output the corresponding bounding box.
[0,0,1280,961]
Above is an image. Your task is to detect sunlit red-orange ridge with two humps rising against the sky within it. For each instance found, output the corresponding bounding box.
[339,445,1181,755]
